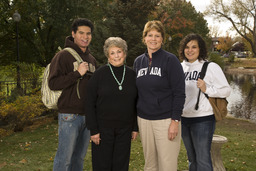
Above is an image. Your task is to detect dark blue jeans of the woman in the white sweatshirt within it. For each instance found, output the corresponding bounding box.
[182,120,216,171]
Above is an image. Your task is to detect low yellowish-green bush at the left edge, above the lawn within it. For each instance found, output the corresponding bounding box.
[0,92,46,131]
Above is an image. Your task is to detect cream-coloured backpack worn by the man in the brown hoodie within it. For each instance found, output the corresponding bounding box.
[41,48,83,109]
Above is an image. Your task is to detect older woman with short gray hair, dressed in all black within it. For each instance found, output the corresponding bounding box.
[86,37,138,171]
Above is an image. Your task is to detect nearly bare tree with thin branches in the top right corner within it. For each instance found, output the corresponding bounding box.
[205,0,256,57]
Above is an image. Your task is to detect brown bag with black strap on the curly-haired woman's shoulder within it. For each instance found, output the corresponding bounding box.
[195,62,228,121]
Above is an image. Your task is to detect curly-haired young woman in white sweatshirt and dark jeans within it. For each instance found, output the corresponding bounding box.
[179,34,231,171]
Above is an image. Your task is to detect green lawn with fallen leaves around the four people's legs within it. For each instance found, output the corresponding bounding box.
[0,118,256,171]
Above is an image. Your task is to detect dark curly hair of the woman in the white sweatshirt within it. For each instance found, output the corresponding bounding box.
[179,33,207,61]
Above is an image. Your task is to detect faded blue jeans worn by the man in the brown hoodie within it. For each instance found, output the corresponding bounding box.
[53,113,90,171]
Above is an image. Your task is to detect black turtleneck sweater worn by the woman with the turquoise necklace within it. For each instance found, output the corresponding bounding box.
[86,65,138,135]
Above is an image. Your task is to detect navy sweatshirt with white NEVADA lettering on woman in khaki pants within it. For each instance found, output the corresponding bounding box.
[134,49,185,120]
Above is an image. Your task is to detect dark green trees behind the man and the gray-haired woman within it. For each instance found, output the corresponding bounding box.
[0,0,159,66]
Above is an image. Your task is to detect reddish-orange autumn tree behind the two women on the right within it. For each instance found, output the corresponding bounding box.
[151,0,210,55]
